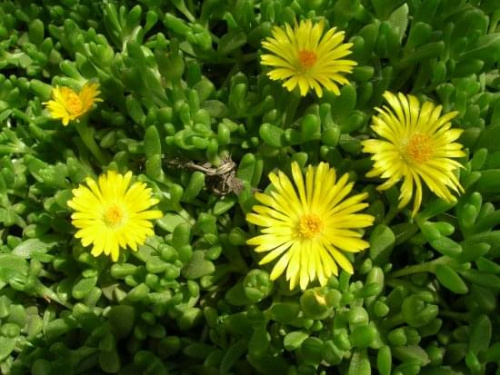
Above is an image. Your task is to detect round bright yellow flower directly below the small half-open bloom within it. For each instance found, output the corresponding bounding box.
[68,171,163,262]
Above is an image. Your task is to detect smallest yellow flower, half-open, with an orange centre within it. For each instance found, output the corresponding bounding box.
[43,82,102,126]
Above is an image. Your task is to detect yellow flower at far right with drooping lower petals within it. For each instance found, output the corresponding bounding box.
[362,92,465,216]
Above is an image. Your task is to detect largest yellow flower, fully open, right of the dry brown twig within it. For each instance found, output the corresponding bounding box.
[246,162,374,290]
